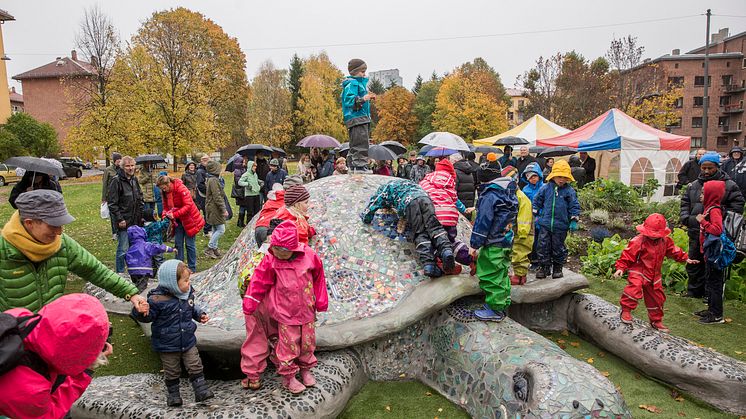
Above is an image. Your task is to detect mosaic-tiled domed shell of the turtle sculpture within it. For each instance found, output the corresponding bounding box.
[192,175,471,331]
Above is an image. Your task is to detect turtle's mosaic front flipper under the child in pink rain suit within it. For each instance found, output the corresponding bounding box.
[72,350,367,419]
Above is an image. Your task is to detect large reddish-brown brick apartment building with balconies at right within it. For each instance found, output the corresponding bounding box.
[632,28,746,152]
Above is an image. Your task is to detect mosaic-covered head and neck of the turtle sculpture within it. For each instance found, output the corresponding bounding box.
[359,299,631,418]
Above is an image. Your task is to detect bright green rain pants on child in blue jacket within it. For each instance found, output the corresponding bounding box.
[477,246,512,311]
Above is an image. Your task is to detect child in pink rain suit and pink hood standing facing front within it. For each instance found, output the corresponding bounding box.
[243,221,329,394]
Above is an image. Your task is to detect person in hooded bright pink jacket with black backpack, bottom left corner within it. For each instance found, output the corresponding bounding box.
[0,294,112,419]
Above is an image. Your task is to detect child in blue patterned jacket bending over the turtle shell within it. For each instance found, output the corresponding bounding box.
[360,179,456,278]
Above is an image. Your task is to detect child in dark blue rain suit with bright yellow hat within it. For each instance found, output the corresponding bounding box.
[533,160,580,279]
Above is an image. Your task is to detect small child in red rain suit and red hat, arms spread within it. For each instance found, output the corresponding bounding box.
[614,213,698,333]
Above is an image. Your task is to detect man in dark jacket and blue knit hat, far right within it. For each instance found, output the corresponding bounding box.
[679,152,744,298]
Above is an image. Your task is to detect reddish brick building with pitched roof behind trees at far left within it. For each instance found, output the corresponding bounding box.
[13,50,96,151]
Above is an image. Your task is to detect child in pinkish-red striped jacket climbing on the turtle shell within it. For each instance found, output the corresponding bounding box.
[420,159,474,274]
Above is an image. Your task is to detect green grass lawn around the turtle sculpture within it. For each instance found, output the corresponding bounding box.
[0,176,746,418]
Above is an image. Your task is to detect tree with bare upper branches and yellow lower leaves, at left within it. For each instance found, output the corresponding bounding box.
[65,6,132,166]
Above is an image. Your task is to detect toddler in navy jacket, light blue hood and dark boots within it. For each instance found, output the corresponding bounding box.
[132,259,213,406]
